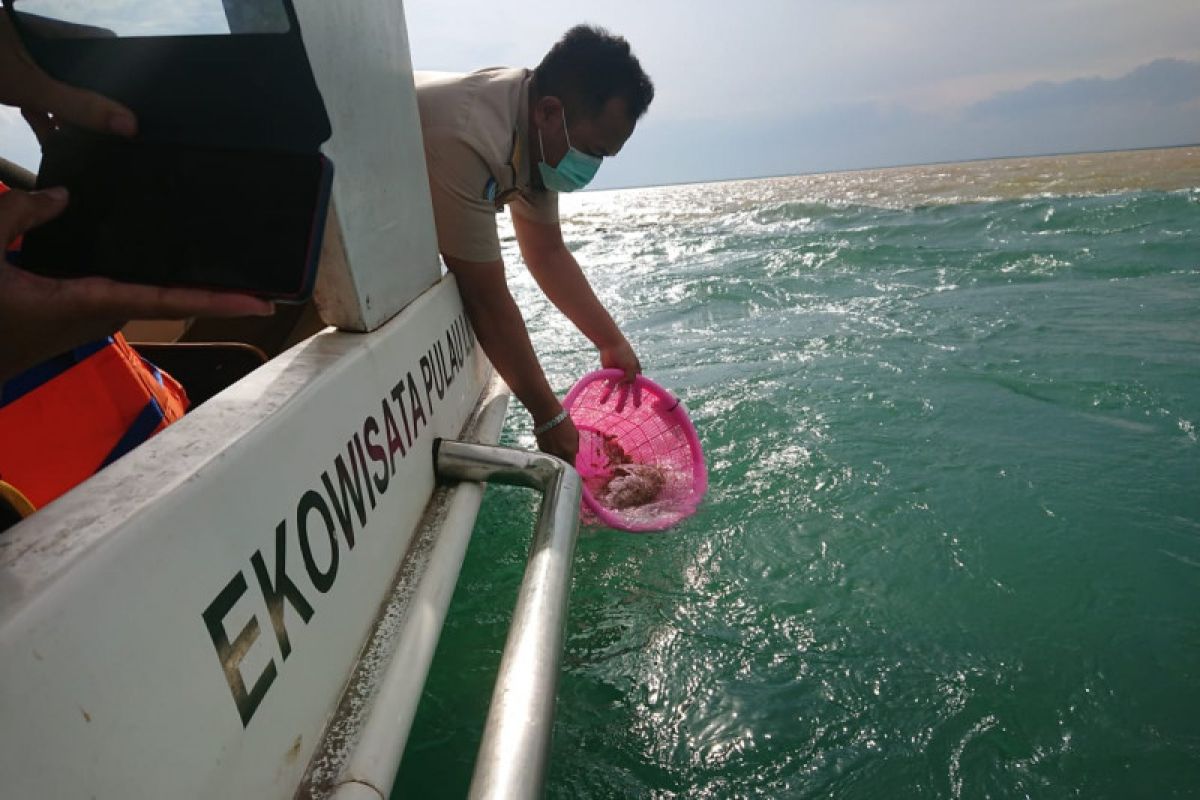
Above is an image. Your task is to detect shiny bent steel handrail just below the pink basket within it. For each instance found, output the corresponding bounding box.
[434,440,582,800]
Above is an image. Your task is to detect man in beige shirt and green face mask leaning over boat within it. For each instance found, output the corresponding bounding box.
[416,25,654,463]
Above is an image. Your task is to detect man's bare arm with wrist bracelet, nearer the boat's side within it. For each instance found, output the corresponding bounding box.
[442,253,580,464]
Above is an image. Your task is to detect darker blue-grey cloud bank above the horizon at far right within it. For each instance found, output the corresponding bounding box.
[967,59,1200,118]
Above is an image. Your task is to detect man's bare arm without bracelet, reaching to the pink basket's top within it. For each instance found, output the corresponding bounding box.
[512,213,642,380]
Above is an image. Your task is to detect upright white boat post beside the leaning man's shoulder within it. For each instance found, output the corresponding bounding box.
[295,0,442,331]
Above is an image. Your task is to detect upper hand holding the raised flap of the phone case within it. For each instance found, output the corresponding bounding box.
[0,13,138,138]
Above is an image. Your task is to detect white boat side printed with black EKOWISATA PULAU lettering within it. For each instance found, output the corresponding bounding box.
[0,278,488,799]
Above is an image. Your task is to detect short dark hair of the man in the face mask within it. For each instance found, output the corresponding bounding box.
[533,25,654,122]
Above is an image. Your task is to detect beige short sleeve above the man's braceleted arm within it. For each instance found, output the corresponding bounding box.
[425,131,500,261]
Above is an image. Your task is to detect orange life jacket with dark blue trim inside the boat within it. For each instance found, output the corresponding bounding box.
[0,184,187,507]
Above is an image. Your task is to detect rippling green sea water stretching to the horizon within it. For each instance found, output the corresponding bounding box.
[395,148,1200,798]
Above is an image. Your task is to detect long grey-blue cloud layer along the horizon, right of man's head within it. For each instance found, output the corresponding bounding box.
[598,59,1200,188]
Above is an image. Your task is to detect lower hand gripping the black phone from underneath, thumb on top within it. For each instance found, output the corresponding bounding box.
[0,188,274,381]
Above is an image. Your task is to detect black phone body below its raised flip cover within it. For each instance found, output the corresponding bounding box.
[19,130,332,302]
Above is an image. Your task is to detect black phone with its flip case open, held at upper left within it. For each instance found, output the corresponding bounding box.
[4,0,332,301]
